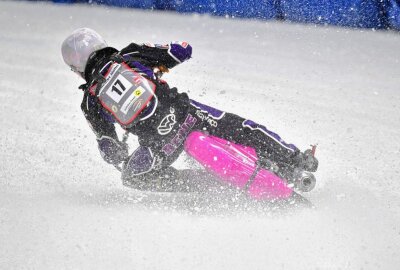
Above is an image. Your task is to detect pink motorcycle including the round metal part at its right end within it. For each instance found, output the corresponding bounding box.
[184,131,316,201]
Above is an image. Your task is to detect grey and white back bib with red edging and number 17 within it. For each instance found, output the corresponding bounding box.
[91,63,156,128]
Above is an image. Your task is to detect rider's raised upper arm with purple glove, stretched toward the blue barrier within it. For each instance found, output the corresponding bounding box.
[120,42,192,68]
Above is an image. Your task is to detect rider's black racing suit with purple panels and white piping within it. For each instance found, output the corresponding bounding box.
[81,43,300,189]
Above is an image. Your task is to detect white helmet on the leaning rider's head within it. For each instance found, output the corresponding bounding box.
[61,28,107,73]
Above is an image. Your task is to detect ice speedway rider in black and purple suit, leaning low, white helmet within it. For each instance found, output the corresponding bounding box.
[61,28,318,189]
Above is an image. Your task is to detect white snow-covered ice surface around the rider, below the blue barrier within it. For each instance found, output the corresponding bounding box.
[0,1,400,269]
